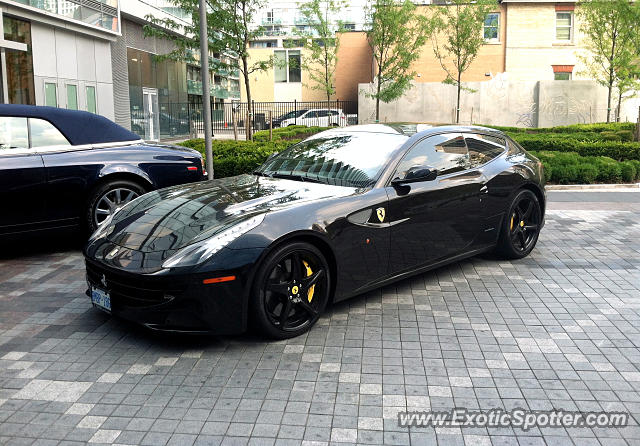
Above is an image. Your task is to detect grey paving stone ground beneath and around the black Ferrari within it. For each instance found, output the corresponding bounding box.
[0,192,640,446]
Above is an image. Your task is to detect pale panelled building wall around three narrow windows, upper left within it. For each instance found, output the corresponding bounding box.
[31,22,114,119]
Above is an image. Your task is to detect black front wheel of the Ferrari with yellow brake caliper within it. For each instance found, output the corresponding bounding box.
[250,242,331,339]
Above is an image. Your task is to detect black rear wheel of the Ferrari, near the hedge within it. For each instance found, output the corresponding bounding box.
[495,189,542,259]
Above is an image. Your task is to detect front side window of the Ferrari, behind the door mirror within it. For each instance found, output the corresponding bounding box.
[393,133,469,178]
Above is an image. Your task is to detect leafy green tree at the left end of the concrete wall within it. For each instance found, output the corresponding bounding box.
[367,0,431,121]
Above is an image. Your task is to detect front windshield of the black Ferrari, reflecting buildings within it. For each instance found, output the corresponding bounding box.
[257,132,407,187]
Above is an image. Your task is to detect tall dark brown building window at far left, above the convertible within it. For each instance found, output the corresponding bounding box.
[3,16,36,105]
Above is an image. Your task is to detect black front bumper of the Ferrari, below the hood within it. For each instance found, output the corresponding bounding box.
[86,259,250,334]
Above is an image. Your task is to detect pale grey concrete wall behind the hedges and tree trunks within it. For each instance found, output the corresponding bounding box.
[358,76,638,127]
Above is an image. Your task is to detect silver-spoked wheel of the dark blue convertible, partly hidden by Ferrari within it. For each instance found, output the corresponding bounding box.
[85,180,147,233]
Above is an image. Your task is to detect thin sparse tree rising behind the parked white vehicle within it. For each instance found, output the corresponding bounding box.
[298,0,345,102]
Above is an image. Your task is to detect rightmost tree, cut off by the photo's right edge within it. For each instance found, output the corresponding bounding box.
[577,0,640,122]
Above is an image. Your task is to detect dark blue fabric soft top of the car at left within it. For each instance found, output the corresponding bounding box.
[0,104,140,146]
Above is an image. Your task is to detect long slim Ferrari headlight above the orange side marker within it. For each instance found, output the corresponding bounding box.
[162,214,264,268]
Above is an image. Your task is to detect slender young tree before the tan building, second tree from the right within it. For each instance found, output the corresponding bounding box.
[432,0,497,123]
